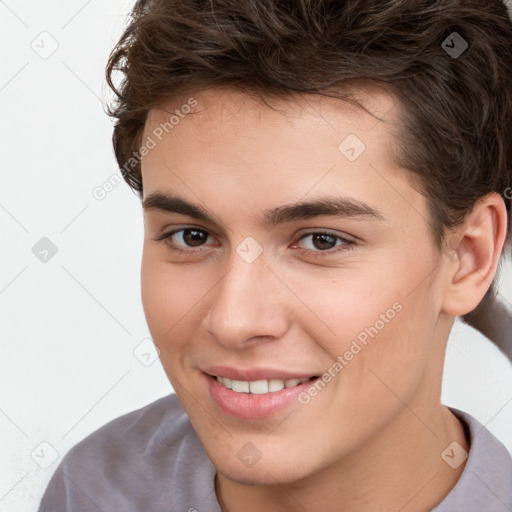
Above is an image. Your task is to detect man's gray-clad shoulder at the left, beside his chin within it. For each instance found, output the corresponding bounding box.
[39,395,218,512]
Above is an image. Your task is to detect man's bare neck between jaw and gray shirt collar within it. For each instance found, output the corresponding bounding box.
[215,405,469,512]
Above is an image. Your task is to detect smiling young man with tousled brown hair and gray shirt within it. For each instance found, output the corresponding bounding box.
[40,0,512,512]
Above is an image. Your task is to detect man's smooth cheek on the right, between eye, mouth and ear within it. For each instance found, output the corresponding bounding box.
[296,265,436,396]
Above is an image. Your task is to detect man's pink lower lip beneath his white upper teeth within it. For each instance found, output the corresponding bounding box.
[205,374,314,420]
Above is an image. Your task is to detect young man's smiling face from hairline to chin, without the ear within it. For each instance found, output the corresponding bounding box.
[142,89,450,483]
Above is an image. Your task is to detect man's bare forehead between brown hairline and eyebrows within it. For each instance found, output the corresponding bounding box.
[138,85,427,238]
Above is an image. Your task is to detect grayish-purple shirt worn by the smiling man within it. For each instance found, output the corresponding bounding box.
[39,394,512,512]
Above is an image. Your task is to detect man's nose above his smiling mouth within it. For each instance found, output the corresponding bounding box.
[203,254,291,349]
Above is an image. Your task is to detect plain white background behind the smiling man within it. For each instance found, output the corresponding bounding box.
[0,0,512,512]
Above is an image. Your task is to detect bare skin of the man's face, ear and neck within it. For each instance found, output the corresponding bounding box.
[137,85,506,512]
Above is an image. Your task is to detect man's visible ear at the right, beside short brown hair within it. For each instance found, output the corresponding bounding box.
[442,192,508,316]
